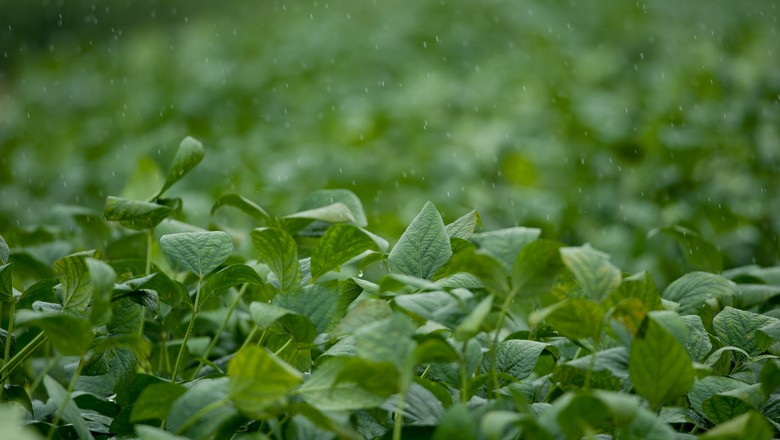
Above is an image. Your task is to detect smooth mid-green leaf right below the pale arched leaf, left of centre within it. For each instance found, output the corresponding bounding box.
[311,224,375,281]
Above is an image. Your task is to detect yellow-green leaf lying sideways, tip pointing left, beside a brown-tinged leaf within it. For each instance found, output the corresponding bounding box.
[529,298,605,339]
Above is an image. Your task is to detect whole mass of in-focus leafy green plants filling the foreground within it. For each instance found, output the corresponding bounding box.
[0,137,780,440]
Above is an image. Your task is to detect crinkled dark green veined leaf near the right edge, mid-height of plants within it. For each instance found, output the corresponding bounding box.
[712,307,780,356]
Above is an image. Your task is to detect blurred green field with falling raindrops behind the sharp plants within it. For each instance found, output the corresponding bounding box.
[0,0,780,284]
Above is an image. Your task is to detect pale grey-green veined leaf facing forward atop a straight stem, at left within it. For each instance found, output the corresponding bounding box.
[160,231,233,277]
